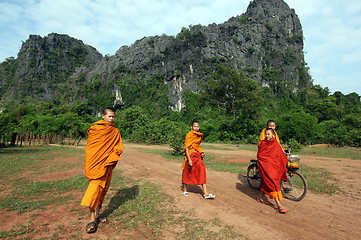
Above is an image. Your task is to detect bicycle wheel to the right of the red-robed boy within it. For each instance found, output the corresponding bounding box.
[281,172,308,201]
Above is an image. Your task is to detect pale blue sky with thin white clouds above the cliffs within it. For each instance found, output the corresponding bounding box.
[0,0,361,95]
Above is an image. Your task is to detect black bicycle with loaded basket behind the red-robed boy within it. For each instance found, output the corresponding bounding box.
[247,151,308,201]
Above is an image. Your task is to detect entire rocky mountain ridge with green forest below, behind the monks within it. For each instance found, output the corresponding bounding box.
[0,0,361,149]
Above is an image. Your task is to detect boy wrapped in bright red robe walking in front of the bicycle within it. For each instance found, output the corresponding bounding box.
[257,128,288,213]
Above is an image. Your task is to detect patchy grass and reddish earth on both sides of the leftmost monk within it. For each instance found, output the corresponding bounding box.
[0,146,245,239]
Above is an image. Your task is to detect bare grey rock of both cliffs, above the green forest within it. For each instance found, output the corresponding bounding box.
[0,0,311,111]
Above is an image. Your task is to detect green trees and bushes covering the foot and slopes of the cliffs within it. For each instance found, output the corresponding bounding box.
[0,45,361,148]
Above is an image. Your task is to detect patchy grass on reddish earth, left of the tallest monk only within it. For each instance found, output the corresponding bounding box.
[0,146,88,213]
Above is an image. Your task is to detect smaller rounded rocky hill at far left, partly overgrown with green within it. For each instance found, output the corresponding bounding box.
[0,33,103,102]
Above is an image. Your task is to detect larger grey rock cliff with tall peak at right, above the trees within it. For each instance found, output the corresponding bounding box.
[77,0,310,111]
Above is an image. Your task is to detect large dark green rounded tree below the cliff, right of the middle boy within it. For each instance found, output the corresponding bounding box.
[202,64,262,122]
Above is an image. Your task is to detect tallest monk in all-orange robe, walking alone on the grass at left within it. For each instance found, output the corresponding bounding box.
[81,108,123,233]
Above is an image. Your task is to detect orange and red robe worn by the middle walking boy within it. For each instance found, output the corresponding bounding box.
[182,130,206,185]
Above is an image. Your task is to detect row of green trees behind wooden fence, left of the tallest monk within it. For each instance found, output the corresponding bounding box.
[0,99,94,139]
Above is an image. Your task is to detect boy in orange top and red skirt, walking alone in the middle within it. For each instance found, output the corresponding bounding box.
[182,122,215,199]
